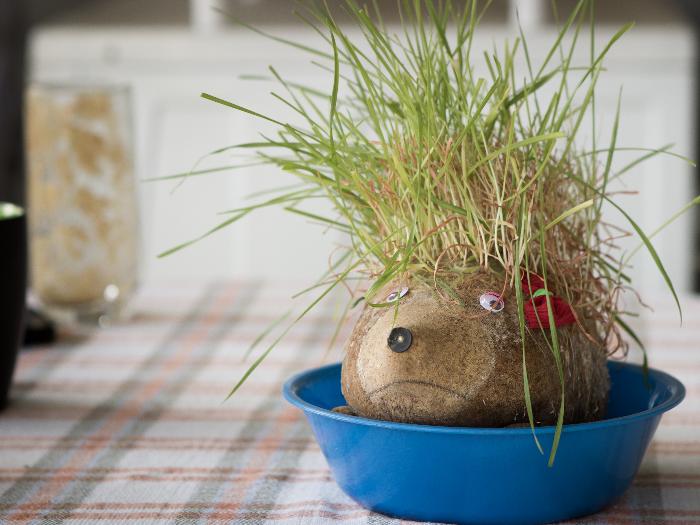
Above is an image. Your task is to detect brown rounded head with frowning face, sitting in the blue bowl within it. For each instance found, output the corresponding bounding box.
[342,274,607,427]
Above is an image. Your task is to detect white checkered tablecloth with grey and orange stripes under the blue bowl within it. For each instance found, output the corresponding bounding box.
[0,282,700,525]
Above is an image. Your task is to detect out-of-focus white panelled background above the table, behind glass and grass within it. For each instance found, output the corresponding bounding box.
[0,0,700,293]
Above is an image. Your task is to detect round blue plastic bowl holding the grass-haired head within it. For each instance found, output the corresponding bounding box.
[284,362,685,524]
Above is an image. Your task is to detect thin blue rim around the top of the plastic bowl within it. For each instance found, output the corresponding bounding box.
[282,360,686,436]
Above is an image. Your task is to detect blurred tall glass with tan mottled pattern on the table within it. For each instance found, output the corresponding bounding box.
[26,84,139,323]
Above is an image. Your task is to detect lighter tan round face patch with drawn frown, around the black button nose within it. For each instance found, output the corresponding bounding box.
[356,292,495,422]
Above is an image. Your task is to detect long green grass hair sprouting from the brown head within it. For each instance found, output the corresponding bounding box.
[166,0,696,461]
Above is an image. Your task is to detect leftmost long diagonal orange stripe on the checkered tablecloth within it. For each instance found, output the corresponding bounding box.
[8,289,241,523]
